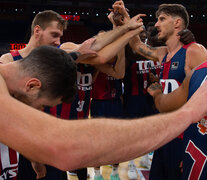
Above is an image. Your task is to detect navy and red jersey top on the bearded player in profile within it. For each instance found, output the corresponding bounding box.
[160,43,191,94]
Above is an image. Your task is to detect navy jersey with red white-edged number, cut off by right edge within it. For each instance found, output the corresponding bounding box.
[182,62,207,180]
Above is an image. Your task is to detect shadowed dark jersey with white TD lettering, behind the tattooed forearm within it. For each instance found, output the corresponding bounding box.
[124,45,161,118]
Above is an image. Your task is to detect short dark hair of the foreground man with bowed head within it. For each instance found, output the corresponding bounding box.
[18,46,77,102]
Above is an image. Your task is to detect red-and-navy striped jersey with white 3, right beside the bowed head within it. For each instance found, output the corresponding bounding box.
[46,64,94,119]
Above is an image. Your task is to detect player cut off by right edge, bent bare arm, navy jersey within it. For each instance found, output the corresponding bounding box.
[148,62,207,179]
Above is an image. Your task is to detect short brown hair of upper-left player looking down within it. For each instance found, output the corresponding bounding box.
[31,10,67,34]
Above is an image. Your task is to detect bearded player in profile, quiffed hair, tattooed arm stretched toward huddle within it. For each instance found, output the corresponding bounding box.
[114,1,207,180]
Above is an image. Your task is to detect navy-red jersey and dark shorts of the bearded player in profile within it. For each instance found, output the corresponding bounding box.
[149,44,194,180]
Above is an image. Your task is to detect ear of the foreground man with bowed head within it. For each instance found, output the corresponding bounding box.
[25,78,42,94]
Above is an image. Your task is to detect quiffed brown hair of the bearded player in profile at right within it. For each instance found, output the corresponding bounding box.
[156,4,189,28]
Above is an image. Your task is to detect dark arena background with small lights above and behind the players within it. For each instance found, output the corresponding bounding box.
[0,0,207,55]
